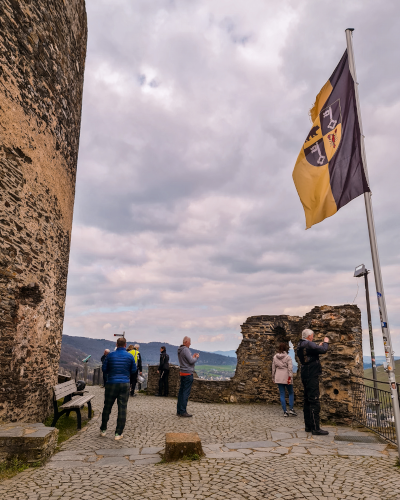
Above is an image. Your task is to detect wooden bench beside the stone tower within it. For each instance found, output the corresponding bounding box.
[51,380,94,429]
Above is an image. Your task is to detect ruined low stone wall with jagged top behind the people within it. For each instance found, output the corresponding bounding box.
[148,305,363,423]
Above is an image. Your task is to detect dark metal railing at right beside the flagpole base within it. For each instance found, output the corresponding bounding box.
[351,379,397,444]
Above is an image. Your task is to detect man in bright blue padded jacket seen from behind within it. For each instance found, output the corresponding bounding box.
[100,338,136,441]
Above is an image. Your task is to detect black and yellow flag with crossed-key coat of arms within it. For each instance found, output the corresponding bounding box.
[293,50,369,229]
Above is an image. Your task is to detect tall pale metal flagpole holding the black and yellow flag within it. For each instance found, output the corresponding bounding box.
[346,28,400,459]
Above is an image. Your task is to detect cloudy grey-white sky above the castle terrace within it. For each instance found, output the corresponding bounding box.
[64,0,400,355]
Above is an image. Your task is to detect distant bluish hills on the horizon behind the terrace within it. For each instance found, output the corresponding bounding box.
[60,335,236,368]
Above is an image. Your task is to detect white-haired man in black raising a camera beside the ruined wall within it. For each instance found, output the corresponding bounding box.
[297,328,329,436]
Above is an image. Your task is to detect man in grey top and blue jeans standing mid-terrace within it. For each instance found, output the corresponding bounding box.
[176,337,199,417]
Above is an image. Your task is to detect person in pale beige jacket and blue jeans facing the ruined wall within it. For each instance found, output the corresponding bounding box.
[272,342,297,417]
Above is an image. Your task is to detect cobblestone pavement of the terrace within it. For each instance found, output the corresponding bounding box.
[0,387,400,500]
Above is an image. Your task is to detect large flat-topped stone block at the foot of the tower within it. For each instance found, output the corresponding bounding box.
[0,423,58,463]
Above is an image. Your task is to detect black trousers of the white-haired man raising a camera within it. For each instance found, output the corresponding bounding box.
[301,363,321,431]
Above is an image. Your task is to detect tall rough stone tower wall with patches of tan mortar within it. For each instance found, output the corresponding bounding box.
[0,0,87,422]
